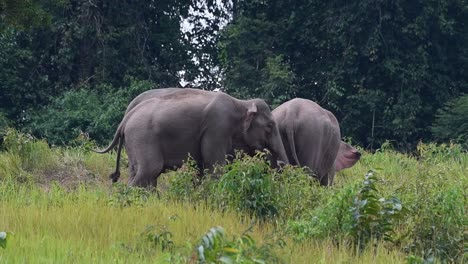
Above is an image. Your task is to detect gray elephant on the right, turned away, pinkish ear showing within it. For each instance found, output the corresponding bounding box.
[272,98,361,186]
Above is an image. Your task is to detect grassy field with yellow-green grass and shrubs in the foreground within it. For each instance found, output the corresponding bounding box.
[0,131,468,263]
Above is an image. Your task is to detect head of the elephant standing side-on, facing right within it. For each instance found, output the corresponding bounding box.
[243,99,289,166]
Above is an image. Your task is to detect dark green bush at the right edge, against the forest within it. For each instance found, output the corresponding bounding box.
[431,95,468,149]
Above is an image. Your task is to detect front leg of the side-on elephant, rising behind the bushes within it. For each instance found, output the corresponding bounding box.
[201,134,231,178]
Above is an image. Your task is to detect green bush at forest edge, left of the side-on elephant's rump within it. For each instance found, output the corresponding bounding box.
[24,80,154,145]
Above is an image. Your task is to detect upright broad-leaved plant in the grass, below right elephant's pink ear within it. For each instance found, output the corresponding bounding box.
[350,171,405,248]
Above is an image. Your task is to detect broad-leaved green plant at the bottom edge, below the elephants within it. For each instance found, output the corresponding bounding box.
[195,226,284,264]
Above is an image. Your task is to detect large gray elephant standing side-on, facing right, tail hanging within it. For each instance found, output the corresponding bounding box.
[99,88,288,187]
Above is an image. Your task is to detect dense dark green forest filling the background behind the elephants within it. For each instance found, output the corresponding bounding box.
[0,0,468,151]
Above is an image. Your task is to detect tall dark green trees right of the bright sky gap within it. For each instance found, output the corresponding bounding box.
[218,0,468,149]
